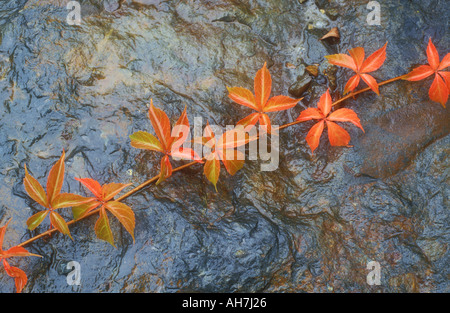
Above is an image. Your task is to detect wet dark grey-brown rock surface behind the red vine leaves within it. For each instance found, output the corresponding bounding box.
[0,0,450,292]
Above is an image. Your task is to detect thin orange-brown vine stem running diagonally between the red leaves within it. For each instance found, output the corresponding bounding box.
[17,75,407,247]
